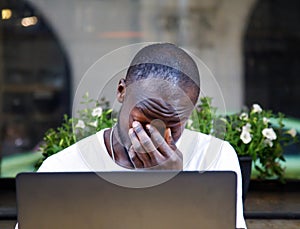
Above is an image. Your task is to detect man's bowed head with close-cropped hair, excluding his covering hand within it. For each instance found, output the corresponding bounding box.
[117,43,200,148]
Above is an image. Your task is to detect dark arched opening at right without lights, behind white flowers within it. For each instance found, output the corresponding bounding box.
[244,0,300,118]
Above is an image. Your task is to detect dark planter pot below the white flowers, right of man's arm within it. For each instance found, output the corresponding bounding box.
[238,156,252,202]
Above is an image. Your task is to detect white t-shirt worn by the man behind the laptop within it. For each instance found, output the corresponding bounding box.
[38,129,246,228]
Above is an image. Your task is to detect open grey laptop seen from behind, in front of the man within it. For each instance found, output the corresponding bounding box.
[16,171,237,229]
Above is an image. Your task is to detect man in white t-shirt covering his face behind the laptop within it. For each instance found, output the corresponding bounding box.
[35,43,246,228]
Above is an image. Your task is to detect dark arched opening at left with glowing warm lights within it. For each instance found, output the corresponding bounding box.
[0,0,71,161]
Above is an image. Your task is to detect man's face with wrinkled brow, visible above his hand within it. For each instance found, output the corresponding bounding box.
[118,79,194,149]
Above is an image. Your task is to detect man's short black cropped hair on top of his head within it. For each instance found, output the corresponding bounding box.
[126,43,200,103]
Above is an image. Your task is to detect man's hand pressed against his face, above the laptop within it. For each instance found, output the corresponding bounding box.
[128,121,183,170]
